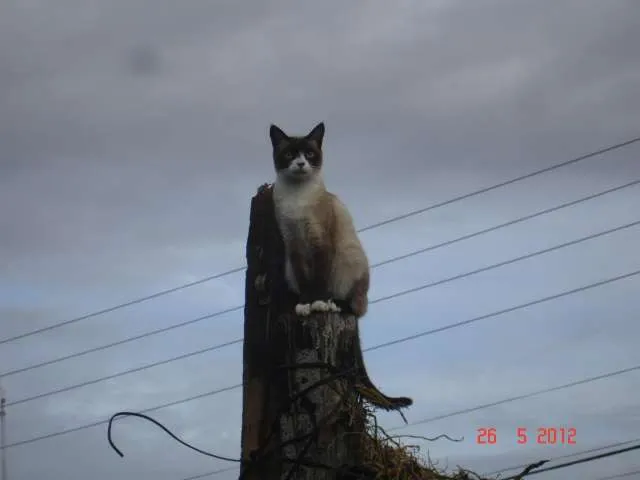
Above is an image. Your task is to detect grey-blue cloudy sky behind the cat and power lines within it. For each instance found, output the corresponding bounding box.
[0,0,640,480]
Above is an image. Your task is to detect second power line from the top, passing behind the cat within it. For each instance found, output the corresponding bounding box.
[6,180,640,377]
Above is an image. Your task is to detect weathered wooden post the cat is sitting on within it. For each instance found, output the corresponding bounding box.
[241,185,365,480]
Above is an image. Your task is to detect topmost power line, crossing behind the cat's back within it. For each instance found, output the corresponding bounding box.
[0,137,640,345]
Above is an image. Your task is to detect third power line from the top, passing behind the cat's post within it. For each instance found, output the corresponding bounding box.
[9,220,640,405]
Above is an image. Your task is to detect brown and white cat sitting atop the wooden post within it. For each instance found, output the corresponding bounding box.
[269,122,413,410]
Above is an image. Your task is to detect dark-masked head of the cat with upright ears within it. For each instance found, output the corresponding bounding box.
[269,122,324,183]
